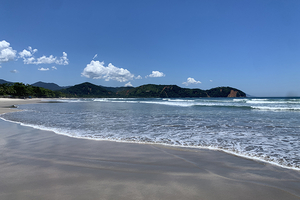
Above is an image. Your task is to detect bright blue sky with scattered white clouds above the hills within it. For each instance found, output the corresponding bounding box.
[0,0,300,97]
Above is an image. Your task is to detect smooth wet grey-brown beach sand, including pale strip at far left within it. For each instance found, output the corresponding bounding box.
[0,100,300,200]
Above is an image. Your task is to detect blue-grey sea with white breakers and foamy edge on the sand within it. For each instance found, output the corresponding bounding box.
[0,98,300,170]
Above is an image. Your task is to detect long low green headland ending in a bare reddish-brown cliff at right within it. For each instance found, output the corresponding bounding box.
[118,84,246,98]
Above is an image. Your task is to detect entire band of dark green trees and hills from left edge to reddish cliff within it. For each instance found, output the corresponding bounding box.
[0,82,246,98]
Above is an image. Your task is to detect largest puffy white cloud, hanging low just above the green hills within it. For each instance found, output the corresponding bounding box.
[81,60,134,82]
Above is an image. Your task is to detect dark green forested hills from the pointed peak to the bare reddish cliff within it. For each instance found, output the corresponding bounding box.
[60,82,246,98]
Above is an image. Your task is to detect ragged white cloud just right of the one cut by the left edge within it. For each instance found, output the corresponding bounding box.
[19,46,69,65]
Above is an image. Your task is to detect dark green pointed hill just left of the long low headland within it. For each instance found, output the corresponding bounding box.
[60,82,115,97]
